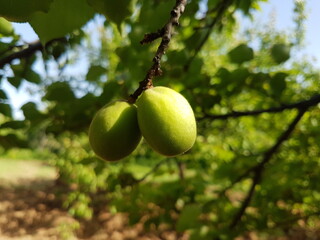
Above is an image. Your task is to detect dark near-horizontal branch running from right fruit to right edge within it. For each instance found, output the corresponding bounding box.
[197,94,320,120]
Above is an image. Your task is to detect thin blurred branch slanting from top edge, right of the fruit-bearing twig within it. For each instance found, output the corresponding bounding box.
[184,0,233,70]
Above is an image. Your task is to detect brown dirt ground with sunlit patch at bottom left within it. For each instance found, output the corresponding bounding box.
[0,159,187,240]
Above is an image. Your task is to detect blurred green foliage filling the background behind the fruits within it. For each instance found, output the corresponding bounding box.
[0,0,320,240]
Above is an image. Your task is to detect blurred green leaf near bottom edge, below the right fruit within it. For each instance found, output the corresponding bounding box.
[176,204,201,232]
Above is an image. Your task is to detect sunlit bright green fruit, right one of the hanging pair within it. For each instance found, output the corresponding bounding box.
[137,87,197,156]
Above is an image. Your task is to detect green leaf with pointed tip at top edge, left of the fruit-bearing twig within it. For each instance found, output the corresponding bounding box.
[87,0,135,29]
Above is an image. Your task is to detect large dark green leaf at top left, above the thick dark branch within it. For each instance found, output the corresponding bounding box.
[29,0,94,44]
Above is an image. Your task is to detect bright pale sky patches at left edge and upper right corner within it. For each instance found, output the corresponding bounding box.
[3,0,320,118]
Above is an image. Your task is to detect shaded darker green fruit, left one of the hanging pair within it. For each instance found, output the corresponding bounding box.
[89,101,141,161]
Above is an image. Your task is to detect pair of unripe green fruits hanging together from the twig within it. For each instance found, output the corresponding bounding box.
[89,87,197,161]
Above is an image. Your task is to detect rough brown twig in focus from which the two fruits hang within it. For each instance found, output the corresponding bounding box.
[128,0,187,103]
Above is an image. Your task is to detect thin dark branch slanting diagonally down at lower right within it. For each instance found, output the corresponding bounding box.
[229,107,308,229]
